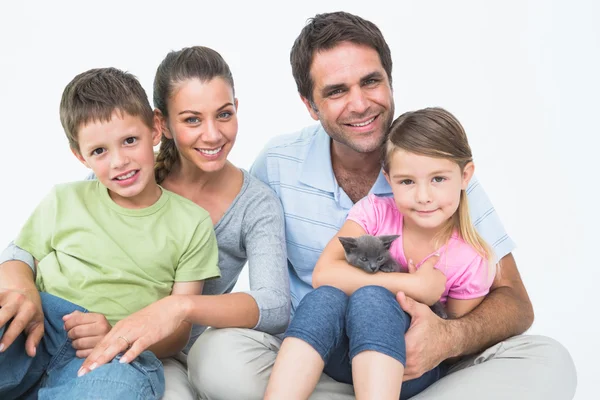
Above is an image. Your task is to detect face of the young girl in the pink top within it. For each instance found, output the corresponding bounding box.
[385,149,474,229]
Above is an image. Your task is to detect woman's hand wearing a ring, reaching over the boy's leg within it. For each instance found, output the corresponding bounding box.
[77,295,188,376]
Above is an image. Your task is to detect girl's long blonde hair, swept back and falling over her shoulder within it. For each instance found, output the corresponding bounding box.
[382,107,495,276]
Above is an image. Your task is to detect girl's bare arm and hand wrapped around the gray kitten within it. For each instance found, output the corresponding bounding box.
[312,220,446,305]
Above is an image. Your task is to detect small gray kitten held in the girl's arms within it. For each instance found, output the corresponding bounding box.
[338,235,448,319]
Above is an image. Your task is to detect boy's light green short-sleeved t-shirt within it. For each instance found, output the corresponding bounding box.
[15,180,220,325]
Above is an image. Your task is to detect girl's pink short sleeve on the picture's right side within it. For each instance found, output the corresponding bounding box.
[448,256,495,300]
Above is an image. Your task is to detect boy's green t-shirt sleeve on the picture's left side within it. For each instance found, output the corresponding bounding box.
[15,187,57,261]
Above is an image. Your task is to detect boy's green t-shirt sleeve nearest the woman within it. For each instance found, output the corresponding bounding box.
[175,217,221,282]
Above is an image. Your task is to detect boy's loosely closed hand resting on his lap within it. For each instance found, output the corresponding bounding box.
[63,311,112,358]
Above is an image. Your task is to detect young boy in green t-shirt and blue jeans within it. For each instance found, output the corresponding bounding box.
[0,68,219,399]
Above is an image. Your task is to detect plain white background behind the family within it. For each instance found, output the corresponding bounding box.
[0,0,600,399]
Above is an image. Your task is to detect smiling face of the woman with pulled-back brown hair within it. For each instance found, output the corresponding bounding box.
[162,77,238,172]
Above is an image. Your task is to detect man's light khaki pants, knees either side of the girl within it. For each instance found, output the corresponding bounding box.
[188,328,577,400]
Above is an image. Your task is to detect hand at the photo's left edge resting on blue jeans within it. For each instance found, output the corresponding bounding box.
[0,289,44,357]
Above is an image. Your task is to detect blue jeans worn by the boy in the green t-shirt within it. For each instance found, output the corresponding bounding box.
[0,293,165,400]
